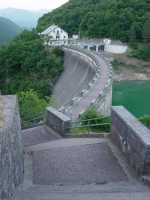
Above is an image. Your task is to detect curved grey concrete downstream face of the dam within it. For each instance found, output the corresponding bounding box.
[53,49,96,108]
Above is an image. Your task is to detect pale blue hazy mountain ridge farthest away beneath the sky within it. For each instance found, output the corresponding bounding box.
[0,8,49,28]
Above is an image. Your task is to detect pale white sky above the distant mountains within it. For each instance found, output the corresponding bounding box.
[0,0,69,11]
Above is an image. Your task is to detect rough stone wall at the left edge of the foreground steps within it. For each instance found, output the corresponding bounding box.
[0,95,24,199]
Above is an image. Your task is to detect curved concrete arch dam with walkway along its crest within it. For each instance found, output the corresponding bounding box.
[53,46,112,121]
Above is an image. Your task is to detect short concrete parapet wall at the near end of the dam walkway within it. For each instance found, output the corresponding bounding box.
[46,107,70,136]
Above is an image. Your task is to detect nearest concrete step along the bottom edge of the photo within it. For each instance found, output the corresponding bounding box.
[12,182,150,200]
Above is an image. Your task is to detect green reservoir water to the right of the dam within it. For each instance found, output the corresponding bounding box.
[112,81,150,117]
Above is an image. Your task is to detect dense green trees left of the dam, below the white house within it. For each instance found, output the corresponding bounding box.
[0,30,63,102]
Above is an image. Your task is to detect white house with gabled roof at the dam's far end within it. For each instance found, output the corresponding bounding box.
[40,24,68,45]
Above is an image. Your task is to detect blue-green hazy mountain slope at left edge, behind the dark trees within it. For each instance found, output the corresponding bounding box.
[0,17,22,46]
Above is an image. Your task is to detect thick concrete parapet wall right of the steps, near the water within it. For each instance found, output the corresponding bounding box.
[110,106,150,176]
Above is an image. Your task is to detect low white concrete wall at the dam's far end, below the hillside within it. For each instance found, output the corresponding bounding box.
[104,44,128,53]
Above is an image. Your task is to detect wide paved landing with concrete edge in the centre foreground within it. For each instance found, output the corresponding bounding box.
[25,138,128,185]
